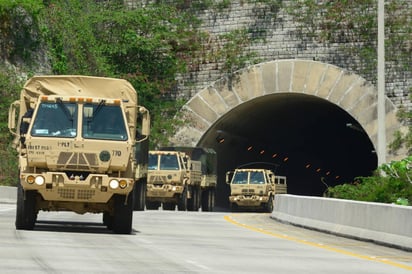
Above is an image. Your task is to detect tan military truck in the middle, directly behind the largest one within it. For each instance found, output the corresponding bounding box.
[146,147,217,211]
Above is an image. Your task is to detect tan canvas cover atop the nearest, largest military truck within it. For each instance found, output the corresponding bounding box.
[21,75,137,105]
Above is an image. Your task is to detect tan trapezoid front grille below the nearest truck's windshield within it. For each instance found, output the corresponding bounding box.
[57,152,98,170]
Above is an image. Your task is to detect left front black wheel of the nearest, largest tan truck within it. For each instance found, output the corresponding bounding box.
[15,184,37,230]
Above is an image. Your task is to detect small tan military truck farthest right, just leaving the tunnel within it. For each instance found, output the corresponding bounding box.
[226,168,287,212]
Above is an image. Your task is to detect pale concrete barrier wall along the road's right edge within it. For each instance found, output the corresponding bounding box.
[271,194,412,250]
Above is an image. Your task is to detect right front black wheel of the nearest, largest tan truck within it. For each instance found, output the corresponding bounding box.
[113,194,133,234]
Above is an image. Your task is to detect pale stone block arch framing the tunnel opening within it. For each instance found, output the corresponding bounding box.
[171,59,405,161]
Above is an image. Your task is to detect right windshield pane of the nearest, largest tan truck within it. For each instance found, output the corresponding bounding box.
[82,101,128,141]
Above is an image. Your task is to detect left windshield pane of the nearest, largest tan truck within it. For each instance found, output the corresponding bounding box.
[30,101,77,138]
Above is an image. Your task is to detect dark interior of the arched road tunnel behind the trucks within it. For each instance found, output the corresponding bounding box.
[198,93,377,208]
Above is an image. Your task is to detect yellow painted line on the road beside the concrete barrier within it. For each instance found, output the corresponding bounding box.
[223,215,412,270]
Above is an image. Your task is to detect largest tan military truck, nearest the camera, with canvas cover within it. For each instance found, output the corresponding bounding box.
[8,75,150,234]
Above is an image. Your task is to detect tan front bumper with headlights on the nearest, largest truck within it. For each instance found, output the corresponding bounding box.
[20,172,134,203]
